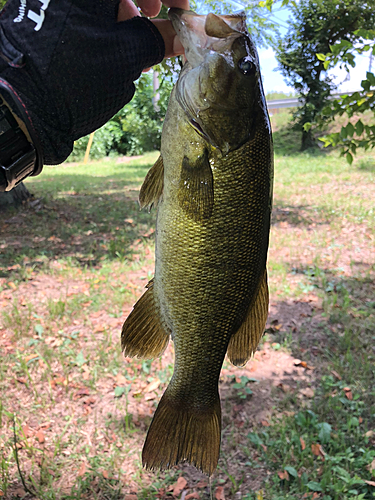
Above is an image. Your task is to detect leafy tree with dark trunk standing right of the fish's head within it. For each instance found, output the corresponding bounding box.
[274,0,374,150]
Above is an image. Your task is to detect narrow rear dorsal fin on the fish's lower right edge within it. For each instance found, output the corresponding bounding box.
[227,269,269,366]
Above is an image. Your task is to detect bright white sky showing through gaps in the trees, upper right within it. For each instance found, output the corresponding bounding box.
[200,0,375,94]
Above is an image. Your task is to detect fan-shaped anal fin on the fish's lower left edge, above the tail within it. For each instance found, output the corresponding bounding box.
[121,280,170,359]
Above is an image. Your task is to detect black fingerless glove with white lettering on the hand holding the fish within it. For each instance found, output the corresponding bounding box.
[0,0,165,164]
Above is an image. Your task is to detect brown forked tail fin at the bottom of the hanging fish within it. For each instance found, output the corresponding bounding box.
[142,388,221,476]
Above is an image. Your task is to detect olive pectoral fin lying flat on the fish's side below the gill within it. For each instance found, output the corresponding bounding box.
[178,150,214,222]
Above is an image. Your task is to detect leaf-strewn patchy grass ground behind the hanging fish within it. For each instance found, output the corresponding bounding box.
[0,134,375,500]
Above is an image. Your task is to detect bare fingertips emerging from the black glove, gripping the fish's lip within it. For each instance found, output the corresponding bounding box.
[117,0,190,57]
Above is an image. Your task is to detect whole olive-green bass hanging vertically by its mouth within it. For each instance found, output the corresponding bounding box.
[121,8,273,476]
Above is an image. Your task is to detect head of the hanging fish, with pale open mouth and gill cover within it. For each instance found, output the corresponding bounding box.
[169,8,267,154]
